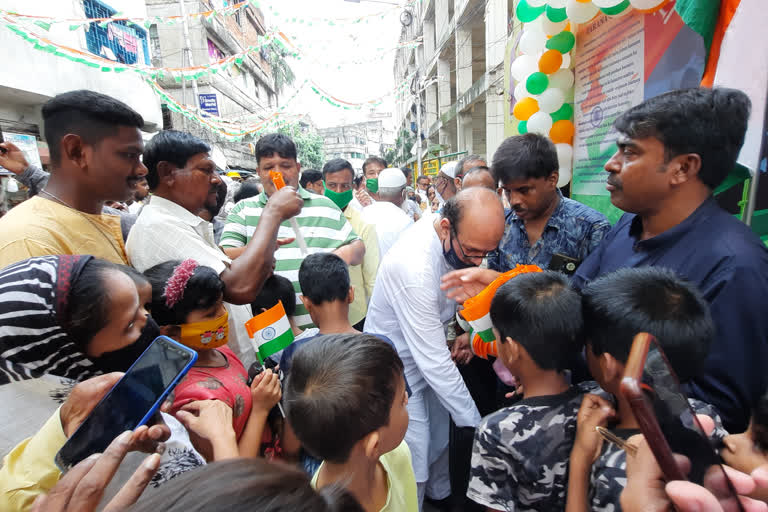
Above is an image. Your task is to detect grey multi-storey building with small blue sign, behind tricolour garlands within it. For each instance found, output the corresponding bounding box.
[146,0,278,169]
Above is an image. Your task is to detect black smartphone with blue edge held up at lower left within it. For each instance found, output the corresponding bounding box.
[56,336,197,471]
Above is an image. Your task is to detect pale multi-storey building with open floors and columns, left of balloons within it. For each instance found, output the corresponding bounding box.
[395,0,513,171]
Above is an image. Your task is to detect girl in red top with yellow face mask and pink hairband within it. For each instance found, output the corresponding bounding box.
[144,259,281,462]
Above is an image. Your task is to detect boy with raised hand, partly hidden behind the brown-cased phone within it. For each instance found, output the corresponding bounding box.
[566,267,727,512]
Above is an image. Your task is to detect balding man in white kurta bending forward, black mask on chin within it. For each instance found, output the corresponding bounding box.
[365,188,504,503]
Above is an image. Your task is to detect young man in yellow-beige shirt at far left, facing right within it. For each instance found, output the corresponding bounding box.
[0,90,147,268]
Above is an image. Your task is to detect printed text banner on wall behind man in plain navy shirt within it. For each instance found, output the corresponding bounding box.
[571,2,706,222]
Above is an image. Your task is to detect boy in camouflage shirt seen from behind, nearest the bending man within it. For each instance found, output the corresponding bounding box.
[467,272,596,511]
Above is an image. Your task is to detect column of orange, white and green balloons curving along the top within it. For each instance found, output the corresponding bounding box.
[510,0,669,187]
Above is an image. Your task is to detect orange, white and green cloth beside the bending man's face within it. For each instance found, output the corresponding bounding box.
[460,265,541,359]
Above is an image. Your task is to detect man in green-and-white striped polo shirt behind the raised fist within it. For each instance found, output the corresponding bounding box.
[220,133,365,328]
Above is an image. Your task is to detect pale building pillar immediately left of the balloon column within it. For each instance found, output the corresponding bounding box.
[485,0,507,158]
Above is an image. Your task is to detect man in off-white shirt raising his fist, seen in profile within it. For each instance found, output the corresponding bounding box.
[126,130,303,368]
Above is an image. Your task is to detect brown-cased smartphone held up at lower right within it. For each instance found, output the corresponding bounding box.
[619,333,741,509]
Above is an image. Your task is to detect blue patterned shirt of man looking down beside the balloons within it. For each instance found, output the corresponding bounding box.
[488,191,611,272]
